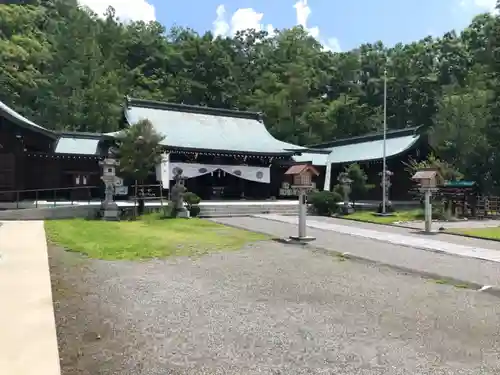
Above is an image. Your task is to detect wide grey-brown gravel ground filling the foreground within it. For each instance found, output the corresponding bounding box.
[50,242,500,375]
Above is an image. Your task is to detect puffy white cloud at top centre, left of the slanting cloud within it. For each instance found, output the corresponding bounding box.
[213,4,274,36]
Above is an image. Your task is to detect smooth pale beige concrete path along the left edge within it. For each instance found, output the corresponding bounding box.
[0,221,60,375]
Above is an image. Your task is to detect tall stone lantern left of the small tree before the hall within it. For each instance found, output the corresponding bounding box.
[99,149,120,221]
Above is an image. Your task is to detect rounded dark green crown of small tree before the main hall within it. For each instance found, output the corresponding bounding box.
[118,120,163,182]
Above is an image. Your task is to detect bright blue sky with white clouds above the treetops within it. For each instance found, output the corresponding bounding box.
[80,0,495,50]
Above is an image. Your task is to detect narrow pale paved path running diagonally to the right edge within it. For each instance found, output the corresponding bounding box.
[255,214,500,262]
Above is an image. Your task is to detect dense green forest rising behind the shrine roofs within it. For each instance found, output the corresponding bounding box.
[0,0,500,188]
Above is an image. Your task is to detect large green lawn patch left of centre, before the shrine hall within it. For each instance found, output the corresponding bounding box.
[45,215,269,260]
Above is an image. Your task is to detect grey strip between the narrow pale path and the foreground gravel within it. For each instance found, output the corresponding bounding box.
[212,217,500,294]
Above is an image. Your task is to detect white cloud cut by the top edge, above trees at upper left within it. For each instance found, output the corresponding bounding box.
[78,0,156,22]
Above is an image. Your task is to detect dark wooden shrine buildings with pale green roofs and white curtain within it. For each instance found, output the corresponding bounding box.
[0,98,430,201]
